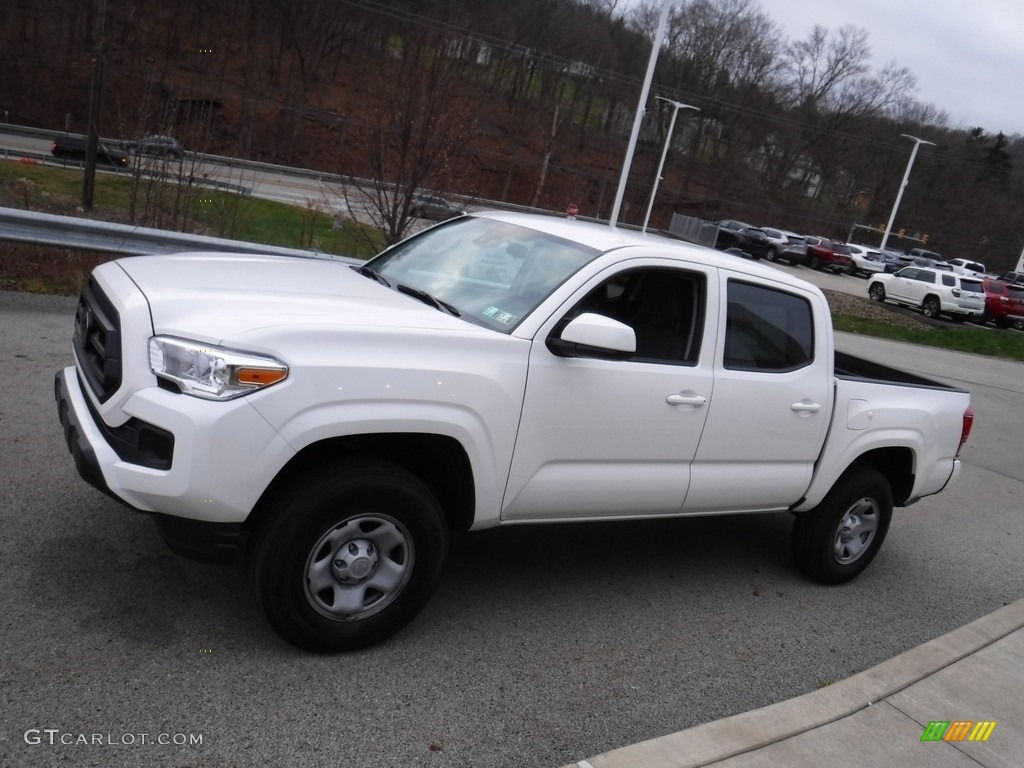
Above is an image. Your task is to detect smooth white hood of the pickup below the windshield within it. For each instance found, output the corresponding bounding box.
[118,253,476,343]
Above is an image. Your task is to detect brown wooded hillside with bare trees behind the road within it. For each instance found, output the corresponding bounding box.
[0,0,1024,268]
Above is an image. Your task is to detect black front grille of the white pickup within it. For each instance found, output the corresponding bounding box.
[73,280,121,402]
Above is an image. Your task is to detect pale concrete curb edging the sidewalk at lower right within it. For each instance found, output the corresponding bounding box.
[563,599,1024,768]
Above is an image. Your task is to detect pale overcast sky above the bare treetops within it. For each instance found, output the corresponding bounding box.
[761,0,1024,135]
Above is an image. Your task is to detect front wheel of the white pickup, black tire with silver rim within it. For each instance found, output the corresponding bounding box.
[249,462,447,651]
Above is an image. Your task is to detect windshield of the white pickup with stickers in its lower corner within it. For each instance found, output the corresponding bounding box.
[367,216,600,333]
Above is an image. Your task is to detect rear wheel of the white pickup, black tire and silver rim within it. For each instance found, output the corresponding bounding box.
[793,466,893,584]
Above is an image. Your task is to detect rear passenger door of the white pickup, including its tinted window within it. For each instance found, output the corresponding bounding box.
[684,271,834,513]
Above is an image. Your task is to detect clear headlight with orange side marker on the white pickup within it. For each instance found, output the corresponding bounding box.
[150,336,288,400]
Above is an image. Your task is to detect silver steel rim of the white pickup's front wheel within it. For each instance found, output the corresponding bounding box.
[303,514,416,622]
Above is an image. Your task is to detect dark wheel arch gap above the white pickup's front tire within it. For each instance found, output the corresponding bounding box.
[245,432,476,531]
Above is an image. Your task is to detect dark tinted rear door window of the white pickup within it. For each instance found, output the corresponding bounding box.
[724,281,814,373]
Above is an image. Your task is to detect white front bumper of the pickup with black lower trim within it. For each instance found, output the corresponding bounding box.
[54,367,294,561]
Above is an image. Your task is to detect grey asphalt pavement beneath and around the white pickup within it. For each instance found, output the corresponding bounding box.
[0,290,1024,768]
